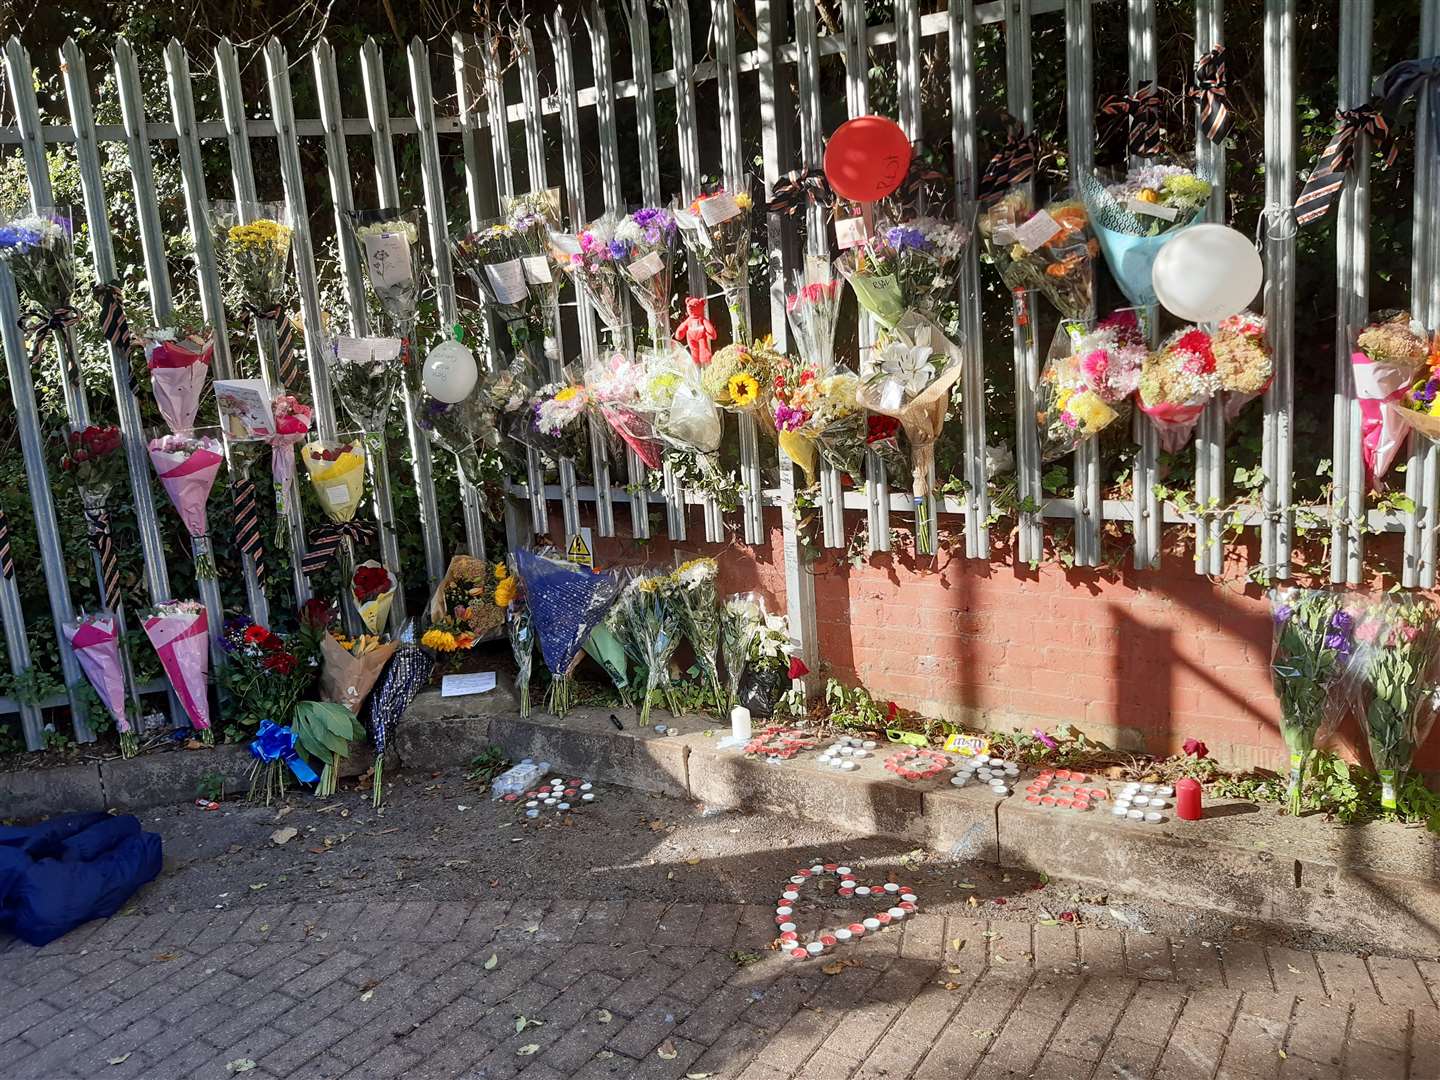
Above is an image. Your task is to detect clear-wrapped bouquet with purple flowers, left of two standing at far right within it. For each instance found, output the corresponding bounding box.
[1270,588,1356,814]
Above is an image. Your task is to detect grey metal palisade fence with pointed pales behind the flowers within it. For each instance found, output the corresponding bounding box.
[0,0,1440,747]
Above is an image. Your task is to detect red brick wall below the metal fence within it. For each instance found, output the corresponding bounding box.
[578,507,1440,769]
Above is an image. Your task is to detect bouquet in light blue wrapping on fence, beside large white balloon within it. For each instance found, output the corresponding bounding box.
[1080,166,1214,307]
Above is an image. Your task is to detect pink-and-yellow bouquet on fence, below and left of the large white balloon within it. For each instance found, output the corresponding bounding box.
[1035,321,1149,461]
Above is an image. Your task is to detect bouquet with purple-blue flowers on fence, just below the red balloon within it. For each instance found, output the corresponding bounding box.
[835,217,971,330]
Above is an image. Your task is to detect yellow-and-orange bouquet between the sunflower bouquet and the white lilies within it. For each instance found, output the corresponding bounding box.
[772,360,864,484]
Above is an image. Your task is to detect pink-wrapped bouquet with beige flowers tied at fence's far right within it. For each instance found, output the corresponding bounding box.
[1351,311,1440,482]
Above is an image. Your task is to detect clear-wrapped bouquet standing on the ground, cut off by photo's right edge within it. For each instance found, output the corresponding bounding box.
[1351,595,1440,811]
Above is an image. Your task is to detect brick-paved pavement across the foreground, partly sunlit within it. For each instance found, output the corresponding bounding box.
[0,900,1440,1080]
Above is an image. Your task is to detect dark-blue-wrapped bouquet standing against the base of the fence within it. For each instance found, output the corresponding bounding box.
[513,549,624,716]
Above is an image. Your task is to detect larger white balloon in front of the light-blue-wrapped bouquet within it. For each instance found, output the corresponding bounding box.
[1151,225,1264,323]
